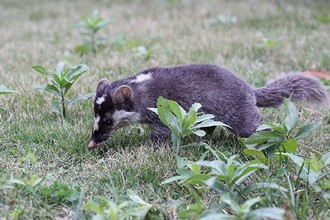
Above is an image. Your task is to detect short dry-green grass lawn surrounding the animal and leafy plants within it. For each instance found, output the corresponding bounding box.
[0,0,330,219]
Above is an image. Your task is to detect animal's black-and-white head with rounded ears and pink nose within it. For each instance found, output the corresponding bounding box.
[88,79,140,149]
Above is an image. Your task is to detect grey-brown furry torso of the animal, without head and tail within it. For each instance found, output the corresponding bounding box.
[135,64,260,137]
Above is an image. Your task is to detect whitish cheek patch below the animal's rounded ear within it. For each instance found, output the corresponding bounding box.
[113,110,140,128]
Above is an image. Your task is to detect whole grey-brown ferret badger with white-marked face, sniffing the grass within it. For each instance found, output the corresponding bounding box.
[88,64,329,149]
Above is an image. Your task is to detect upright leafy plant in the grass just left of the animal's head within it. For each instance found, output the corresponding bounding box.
[32,61,94,118]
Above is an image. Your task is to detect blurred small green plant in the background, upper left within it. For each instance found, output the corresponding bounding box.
[75,11,109,56]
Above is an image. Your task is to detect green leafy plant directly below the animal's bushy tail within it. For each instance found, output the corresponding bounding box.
[244,99,320,161]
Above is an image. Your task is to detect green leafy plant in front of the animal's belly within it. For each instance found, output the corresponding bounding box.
[149,96,228,150]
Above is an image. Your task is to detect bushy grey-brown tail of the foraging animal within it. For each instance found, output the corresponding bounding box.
[255,73,330,107]
